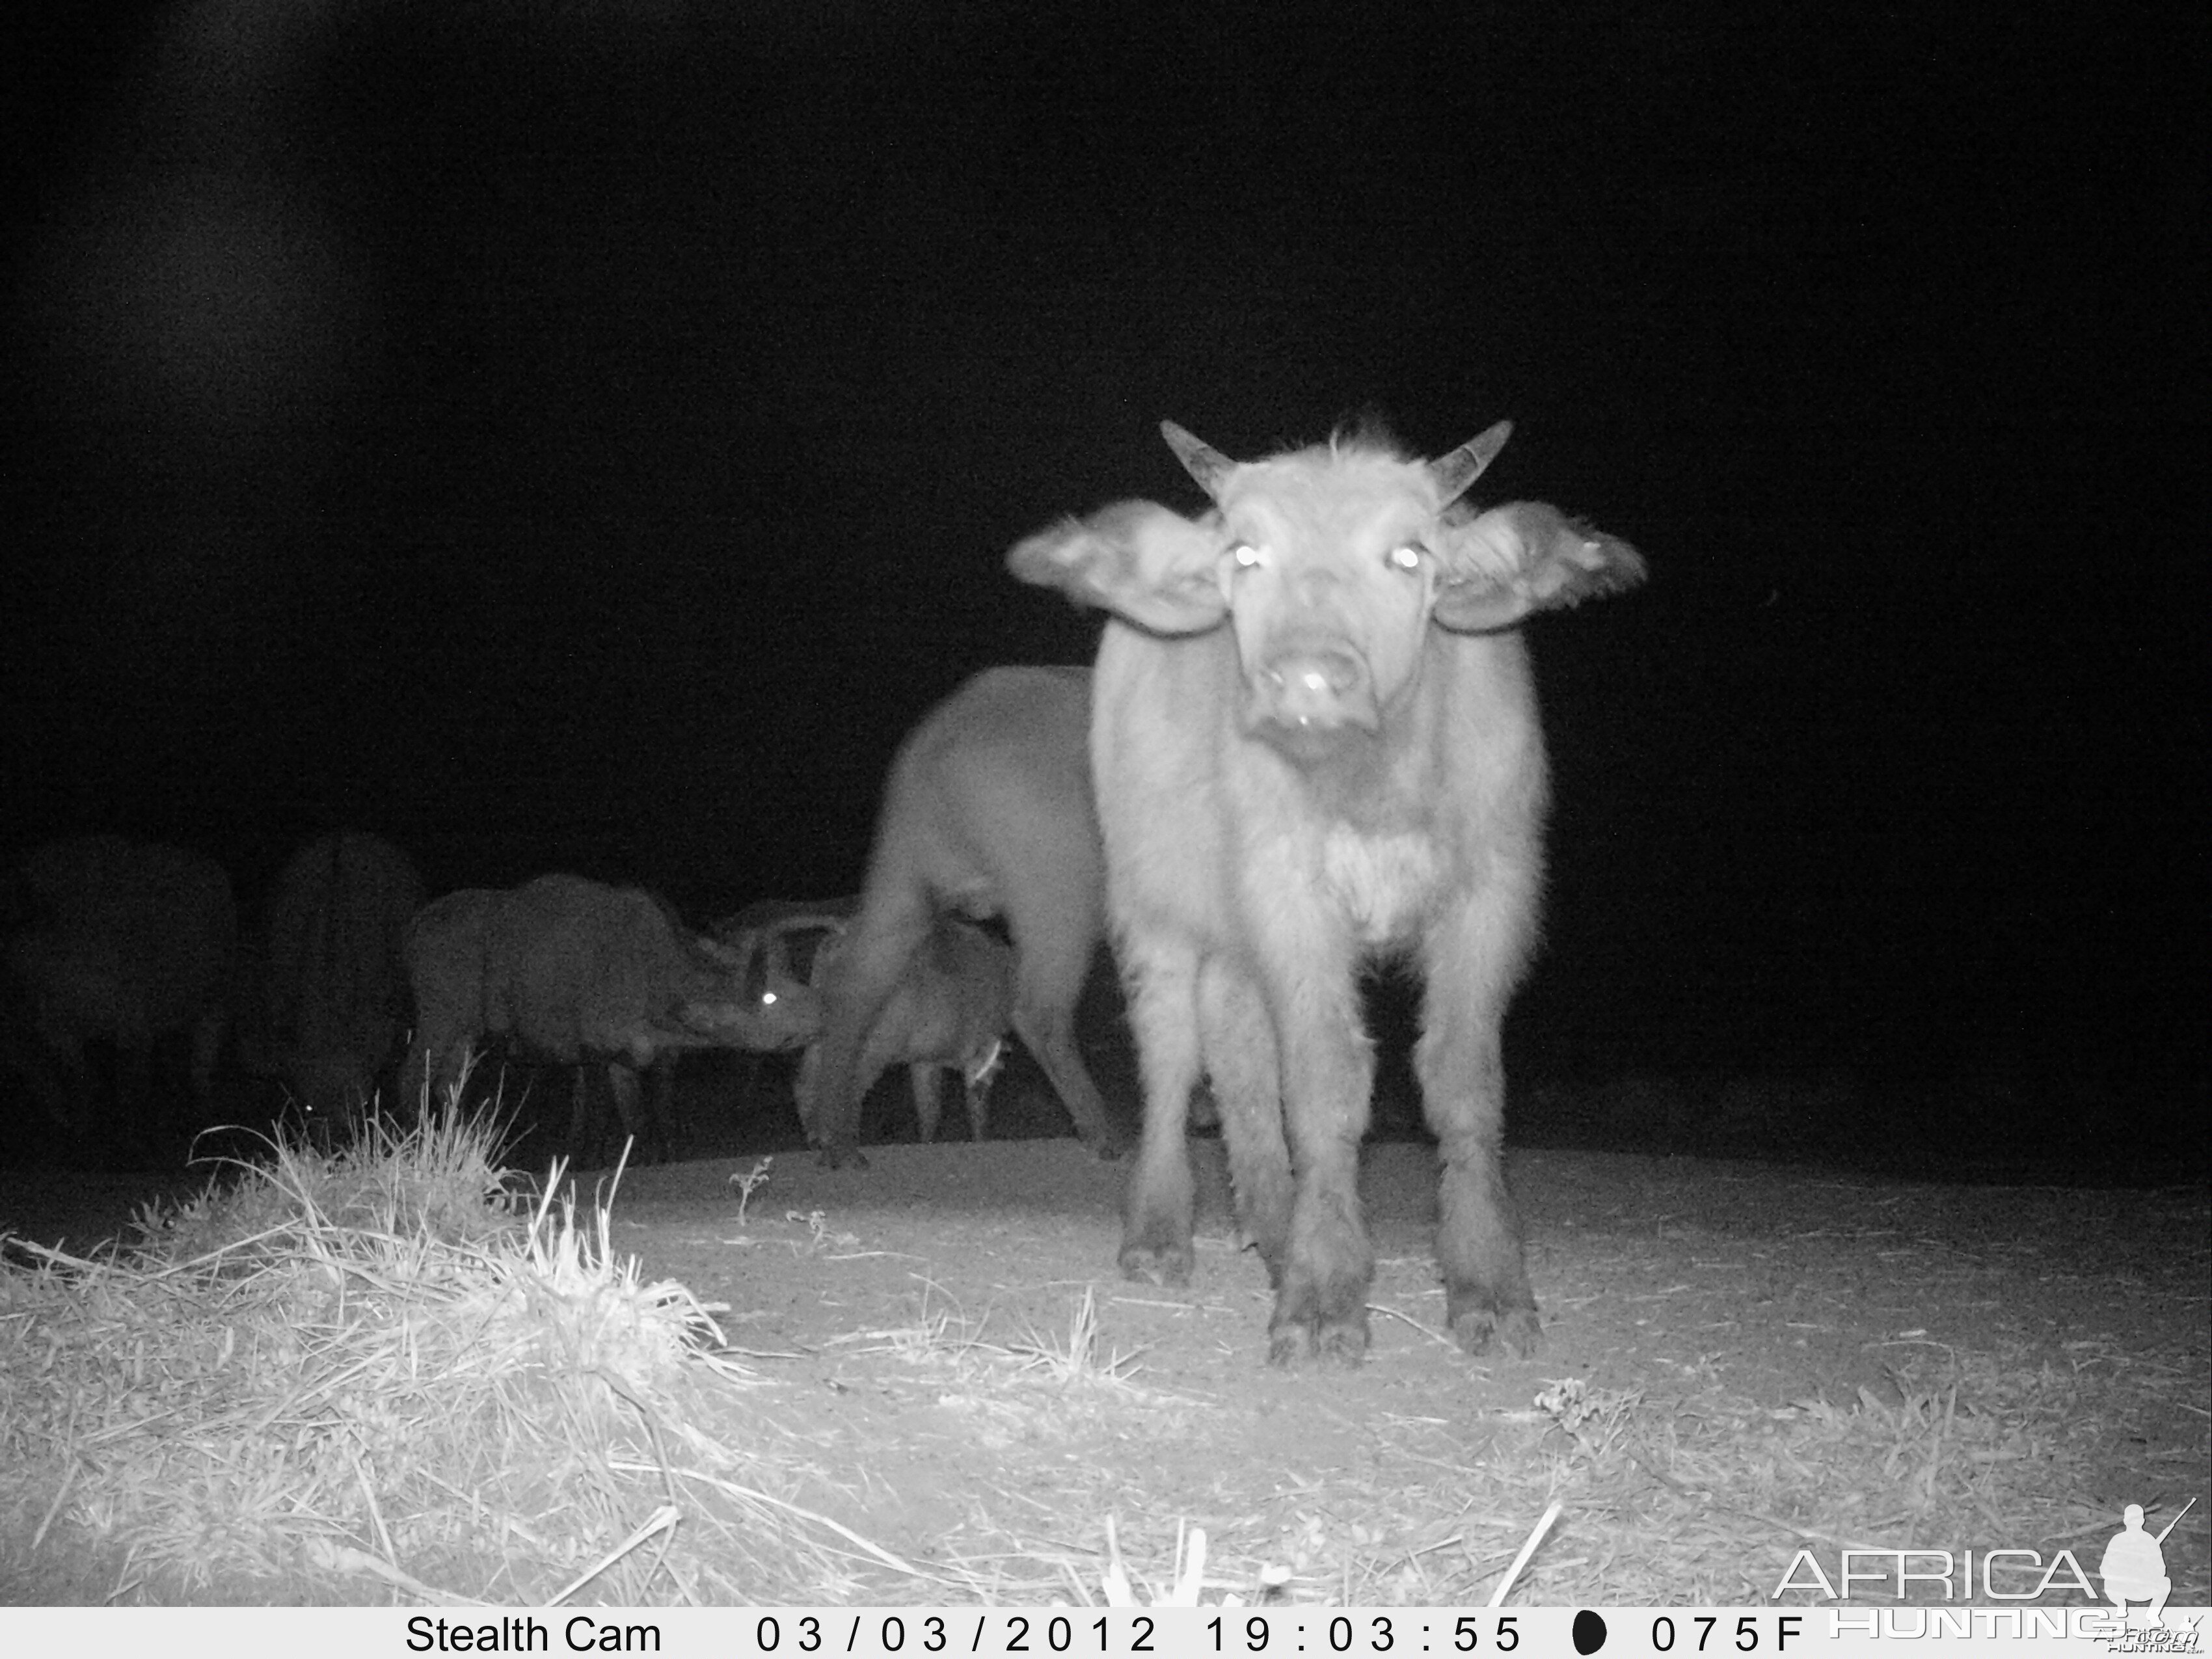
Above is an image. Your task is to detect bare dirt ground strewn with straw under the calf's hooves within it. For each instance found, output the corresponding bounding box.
[12,1139,2212,1606]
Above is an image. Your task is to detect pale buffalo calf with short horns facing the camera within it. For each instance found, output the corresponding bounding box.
[1008,422,1643,1365]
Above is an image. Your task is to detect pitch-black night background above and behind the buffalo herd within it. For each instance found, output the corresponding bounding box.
[0,0,2212,1168]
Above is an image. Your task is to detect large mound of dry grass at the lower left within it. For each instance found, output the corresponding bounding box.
[0,1108,931,1604]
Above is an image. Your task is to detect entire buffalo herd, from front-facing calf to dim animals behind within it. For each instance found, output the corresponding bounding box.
[0,422,1643,1362]
